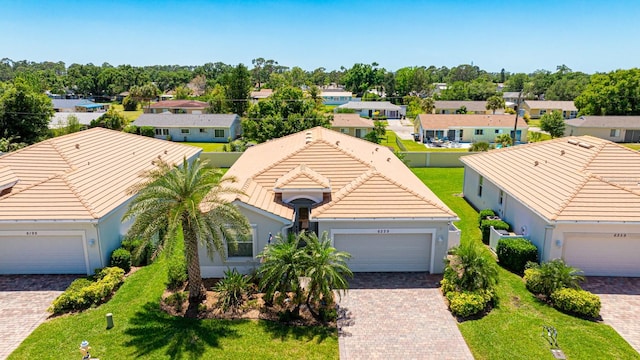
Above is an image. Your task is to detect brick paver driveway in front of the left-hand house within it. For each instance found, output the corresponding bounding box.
[0,275,77,359]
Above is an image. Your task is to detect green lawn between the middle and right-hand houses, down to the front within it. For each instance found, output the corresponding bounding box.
[412,168,640,359]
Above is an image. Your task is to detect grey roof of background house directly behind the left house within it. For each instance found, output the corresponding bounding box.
[132,113,240,128]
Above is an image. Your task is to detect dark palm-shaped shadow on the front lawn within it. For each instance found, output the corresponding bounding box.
[125,302,239,359]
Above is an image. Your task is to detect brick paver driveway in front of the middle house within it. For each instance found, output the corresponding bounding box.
[338,273,473,360]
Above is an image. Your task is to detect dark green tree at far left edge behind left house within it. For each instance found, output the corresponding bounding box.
[0,77,53,144]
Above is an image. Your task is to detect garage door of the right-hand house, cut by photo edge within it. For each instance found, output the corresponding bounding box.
[563,234,640,276]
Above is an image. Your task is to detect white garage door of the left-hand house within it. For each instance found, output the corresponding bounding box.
[0,236,87,274]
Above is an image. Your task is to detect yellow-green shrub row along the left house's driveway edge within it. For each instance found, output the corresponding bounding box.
[49,267,124,314]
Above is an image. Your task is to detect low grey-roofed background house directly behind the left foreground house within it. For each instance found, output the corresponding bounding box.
[132,113,241,142]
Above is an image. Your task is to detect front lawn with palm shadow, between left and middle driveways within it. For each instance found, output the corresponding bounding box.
[9,262,338,360]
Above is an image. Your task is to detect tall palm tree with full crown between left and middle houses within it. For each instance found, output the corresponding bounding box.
[123,158,250,316]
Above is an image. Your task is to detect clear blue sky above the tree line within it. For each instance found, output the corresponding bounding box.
[0,0,640,73]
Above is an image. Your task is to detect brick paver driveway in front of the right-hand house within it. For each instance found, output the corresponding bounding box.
[582,276,640,352]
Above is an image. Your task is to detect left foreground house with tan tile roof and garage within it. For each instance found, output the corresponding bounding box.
[0,128,201,275]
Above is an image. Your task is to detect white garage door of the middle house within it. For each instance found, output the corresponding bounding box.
[334,234,431,272]
